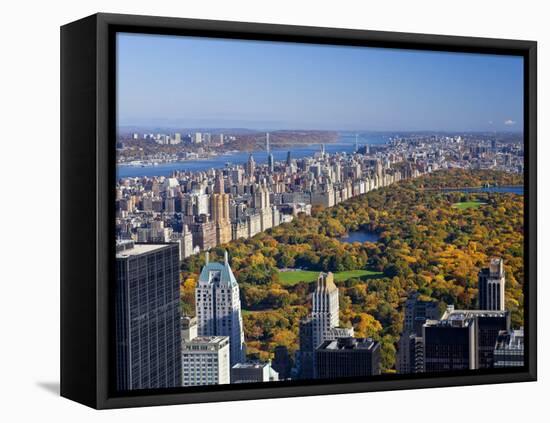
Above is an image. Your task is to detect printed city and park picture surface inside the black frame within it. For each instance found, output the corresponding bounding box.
[113,33,525,391]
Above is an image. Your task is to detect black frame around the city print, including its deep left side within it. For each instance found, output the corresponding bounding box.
[61,13,537,409]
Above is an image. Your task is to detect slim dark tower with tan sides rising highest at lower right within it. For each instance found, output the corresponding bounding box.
[478,257,506,311]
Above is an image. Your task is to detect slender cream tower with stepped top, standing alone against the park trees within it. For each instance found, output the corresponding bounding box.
[311,272,340,348]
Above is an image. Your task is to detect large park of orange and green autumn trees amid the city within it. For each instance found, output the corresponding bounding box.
[180,169,524,372]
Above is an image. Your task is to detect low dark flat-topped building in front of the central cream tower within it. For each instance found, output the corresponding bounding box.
[315,337,380,379]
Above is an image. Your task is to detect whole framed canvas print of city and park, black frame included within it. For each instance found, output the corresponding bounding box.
[61,14,536,408]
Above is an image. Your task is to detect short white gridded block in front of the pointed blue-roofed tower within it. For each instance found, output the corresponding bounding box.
[181,336,231,386]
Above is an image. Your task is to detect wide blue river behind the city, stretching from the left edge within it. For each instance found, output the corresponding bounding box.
[117,133,391,178]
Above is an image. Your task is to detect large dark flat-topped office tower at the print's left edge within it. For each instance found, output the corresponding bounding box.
[115,241,182,390]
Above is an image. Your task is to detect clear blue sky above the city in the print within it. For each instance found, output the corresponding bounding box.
[117,34,523,131]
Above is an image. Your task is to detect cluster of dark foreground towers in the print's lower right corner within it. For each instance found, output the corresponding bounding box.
[396,257,523,373]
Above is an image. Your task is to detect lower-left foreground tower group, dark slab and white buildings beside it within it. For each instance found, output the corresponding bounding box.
[116,245,278,390]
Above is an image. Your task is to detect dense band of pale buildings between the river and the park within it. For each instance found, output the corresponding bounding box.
[116,134,426,259]
